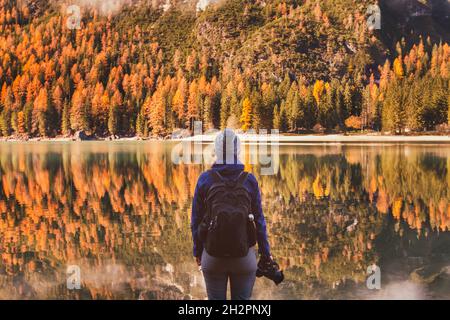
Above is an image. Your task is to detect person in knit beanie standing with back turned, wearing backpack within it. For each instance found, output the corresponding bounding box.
[191,129,273,300]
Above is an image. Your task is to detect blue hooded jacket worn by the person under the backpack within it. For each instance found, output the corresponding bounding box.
[191,163,270,257]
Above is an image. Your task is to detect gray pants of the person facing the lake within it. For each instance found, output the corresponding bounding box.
[202,247,257,300]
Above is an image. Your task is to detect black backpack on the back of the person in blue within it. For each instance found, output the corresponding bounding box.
[199,170,253,258]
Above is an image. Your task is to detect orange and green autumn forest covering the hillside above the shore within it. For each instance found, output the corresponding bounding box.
[0,0,450,137]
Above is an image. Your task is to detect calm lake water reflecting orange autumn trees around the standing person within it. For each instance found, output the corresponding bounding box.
[0,142,450,299]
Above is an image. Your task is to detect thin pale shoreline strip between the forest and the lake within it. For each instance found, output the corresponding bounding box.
[0,134,450,144]
